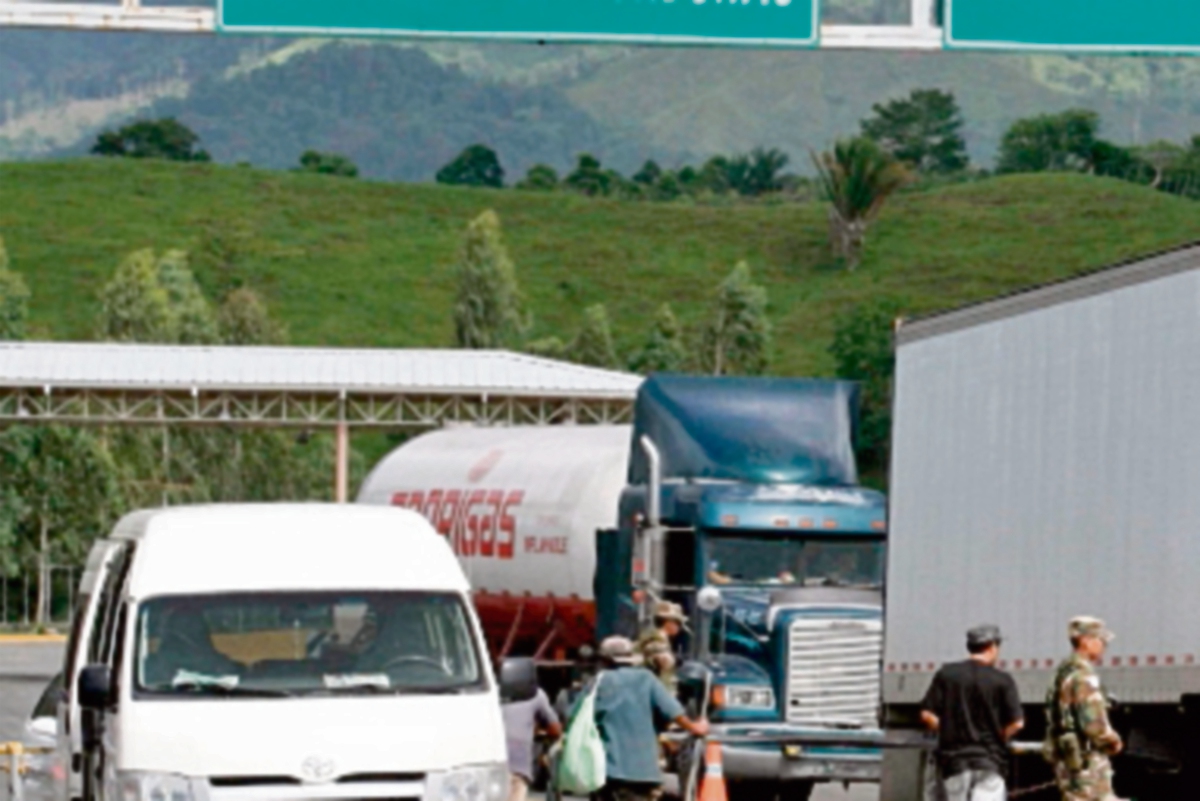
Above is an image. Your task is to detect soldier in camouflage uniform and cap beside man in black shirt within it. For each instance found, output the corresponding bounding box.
[1045,618,1123,801]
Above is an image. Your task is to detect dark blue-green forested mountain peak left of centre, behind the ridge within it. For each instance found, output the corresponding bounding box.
[149,44,667,181]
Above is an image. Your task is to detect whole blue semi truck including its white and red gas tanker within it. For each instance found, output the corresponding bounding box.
[359,375,887,801]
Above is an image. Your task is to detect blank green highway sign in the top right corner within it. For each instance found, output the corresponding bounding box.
[944,0,1200,53]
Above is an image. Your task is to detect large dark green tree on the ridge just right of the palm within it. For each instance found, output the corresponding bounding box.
[862,89,968,173]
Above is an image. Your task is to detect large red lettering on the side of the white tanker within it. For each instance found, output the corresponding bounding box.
[391,489,523,559]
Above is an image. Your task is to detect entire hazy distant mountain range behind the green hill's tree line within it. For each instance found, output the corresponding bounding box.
[7,28,1200,180]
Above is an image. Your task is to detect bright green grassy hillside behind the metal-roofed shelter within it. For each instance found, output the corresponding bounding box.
[0,159,1200,374]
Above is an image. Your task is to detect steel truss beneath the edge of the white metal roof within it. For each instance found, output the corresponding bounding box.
[0,386,632,428]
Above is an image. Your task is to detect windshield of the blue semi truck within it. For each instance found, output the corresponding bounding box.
[706,535,884,586]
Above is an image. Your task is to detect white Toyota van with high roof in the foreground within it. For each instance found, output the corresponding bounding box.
[51,504,534,801]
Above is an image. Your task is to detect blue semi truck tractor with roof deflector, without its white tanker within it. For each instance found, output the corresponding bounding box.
[595,375,887,801]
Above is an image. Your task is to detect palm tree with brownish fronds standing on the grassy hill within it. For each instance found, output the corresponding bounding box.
[812,137,910,270]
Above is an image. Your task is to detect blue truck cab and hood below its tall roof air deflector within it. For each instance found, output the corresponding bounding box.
[595,379,887,801]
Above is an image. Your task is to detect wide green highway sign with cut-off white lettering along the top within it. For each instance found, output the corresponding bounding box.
[216,0,820,47]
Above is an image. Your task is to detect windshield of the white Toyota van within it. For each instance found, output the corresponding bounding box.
[134,592,484,697]
